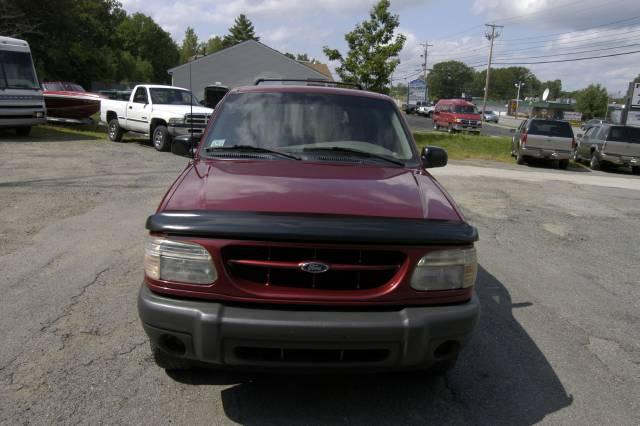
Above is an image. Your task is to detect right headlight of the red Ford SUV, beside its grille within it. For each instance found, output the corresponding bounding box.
[411,247,478,291]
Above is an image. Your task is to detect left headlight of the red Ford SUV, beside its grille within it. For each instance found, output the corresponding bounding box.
[144,237,218,284]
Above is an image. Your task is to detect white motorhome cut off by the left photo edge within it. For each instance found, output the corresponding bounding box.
[0,36,47,136]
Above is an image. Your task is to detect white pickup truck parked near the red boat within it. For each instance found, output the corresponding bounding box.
[100,84,213,151]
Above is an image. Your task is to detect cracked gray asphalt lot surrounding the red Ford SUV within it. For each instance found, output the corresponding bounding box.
[0,134,640,425]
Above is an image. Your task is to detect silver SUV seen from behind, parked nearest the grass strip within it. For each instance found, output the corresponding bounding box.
[511,118,576,169]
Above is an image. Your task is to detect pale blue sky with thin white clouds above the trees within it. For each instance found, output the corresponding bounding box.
[121,0,640,95]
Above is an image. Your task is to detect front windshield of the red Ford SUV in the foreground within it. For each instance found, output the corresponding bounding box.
[203,92,413,160]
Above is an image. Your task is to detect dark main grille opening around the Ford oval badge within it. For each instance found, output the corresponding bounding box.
[222,246,406,290]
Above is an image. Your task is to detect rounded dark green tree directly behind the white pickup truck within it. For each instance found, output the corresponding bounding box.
[116,13,180,83]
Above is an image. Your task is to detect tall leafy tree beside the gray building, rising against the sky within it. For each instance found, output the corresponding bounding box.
[323,0,406,93]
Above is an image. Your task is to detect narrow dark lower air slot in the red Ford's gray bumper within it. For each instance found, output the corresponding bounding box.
[234,346,390,364]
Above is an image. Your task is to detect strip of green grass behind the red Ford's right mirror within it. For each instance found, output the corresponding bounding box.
[413,132,512,162]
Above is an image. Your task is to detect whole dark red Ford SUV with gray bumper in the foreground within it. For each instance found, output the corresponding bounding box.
[138,83,479,371]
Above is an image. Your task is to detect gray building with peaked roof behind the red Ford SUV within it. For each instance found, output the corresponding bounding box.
[168,40,329,99]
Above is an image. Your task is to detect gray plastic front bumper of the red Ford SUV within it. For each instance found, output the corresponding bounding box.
[138,283,480,369]
